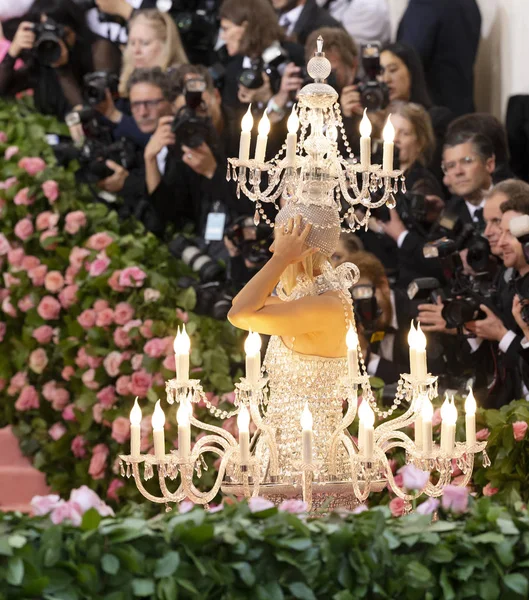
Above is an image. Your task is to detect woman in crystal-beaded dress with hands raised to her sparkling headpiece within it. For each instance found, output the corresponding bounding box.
[228,202,358,483]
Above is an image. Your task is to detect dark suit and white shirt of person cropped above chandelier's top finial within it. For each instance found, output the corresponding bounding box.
[272,0,342,49]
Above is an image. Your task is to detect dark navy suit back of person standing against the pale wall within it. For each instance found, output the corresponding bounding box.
[397,0,481,116]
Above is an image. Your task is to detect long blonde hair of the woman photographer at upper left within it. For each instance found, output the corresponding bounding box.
[119,9,189,98]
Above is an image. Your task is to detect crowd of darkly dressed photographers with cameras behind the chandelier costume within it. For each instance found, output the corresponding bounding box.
[0,0,529,407]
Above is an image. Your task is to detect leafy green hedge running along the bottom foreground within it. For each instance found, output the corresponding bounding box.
[0,498,529,600]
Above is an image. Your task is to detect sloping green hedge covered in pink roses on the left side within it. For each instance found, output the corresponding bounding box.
[0,101,242,500]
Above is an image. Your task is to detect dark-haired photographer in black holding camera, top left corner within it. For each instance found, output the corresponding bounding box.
[0,0,121,118]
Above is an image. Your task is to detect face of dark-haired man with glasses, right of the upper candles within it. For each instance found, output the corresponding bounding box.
[443,142,494,198]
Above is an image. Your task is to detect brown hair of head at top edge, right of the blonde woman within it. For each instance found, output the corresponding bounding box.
[219,0,284,58]
